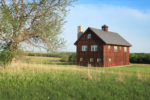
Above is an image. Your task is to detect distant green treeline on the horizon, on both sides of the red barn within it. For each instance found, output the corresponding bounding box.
[17,52,150,64]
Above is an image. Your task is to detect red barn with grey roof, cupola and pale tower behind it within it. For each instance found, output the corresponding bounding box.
[75,25,131,67]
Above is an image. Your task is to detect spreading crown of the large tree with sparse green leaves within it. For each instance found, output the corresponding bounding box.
[0,0,75,62]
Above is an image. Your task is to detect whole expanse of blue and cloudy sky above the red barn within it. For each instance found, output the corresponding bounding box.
[61,0,150,53]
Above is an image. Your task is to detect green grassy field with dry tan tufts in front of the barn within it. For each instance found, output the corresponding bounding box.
[0,57,150,100]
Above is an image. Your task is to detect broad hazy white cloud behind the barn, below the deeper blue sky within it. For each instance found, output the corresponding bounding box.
[63,5,150,52]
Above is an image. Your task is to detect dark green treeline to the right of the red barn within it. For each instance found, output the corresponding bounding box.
[130,53,150,64]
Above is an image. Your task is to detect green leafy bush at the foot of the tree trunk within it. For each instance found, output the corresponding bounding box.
[0,51,15,66]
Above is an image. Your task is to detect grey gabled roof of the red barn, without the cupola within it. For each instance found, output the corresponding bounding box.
[76,27,131,46]
